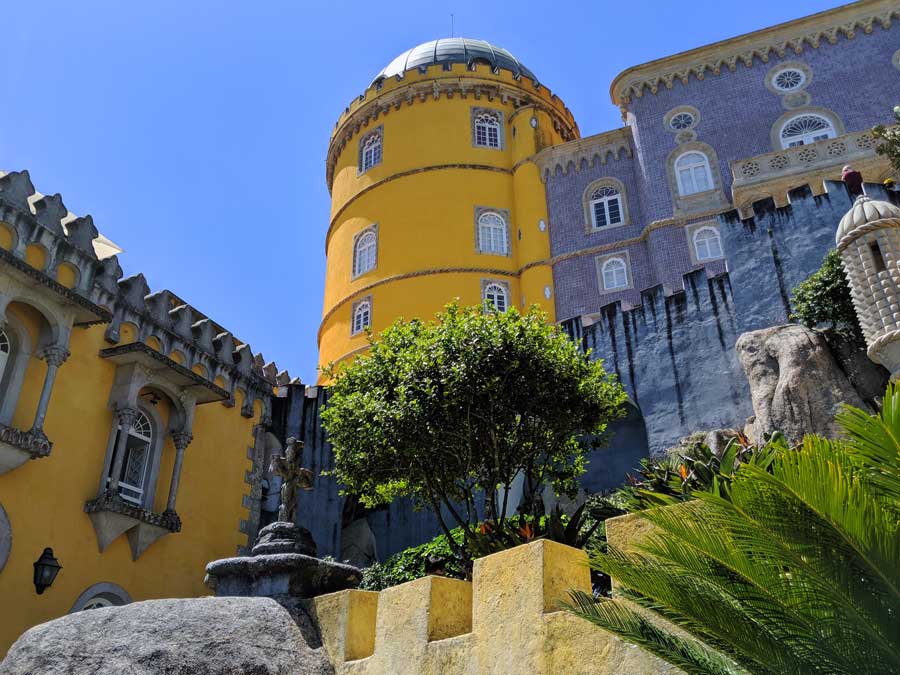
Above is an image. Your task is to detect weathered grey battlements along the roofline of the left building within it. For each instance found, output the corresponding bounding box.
[0,171,291,417]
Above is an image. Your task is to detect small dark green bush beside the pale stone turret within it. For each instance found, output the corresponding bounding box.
[791,249,865,345]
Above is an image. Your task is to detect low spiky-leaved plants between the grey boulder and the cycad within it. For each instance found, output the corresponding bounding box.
[612,434,787,511]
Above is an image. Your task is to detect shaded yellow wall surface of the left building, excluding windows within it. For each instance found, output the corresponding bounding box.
[0,324,256,658]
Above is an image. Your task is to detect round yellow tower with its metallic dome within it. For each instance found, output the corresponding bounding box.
[318,38,578,378]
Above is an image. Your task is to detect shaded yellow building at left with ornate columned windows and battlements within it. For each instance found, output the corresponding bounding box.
[0,172,286,656]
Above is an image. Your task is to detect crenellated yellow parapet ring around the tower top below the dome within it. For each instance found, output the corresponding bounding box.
[325,63,579,190]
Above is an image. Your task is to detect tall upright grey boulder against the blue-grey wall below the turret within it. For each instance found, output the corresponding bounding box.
[735,324,869,442]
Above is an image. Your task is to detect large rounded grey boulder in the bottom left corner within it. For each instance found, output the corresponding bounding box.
[0,598,334,675]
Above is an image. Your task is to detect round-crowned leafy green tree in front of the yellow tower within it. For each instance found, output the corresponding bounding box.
[322,303,626,555]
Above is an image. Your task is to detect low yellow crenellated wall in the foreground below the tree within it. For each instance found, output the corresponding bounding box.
[311,540,677,675]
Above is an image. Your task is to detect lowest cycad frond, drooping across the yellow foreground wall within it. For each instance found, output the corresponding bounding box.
[566,591,746,675]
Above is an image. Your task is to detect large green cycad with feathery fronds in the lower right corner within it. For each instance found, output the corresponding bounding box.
[570,386,900,675]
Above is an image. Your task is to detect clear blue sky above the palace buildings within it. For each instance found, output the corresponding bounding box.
[0,0,835,382]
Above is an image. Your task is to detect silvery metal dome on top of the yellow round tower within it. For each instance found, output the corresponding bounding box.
[372,38,537,84]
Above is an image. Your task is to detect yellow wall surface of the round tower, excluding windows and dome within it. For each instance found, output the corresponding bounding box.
[319,64,577,380]
